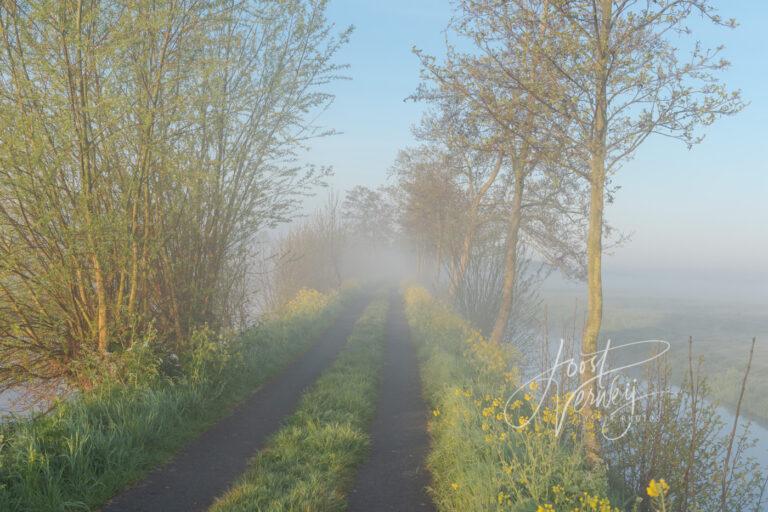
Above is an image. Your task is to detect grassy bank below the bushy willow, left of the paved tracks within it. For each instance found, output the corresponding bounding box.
[0,290,356,512]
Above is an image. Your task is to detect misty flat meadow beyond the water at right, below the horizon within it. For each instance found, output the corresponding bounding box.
[543,289,768,425]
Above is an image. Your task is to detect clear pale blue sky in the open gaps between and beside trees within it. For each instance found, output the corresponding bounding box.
[306,0,768,297]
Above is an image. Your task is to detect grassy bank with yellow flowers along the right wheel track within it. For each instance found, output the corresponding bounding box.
[405,288,616,512]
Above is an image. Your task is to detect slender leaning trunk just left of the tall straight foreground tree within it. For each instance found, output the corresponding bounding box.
[491,165,525,343]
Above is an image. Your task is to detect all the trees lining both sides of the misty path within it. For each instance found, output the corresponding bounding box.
[0,0,743,428]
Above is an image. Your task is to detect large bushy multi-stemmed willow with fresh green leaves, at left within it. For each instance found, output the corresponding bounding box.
[0,0,347,386]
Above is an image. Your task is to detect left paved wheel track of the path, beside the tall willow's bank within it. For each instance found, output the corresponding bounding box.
[104,297,368,512]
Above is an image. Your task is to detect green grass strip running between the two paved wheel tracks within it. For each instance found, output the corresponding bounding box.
[211,299,387,512]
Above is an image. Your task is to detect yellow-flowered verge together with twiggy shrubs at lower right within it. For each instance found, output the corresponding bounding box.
[406,288,764,512]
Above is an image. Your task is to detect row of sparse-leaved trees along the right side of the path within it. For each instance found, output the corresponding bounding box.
[396,0,743,462]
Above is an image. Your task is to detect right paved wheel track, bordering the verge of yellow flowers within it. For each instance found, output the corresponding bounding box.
[347,293,435,512]
